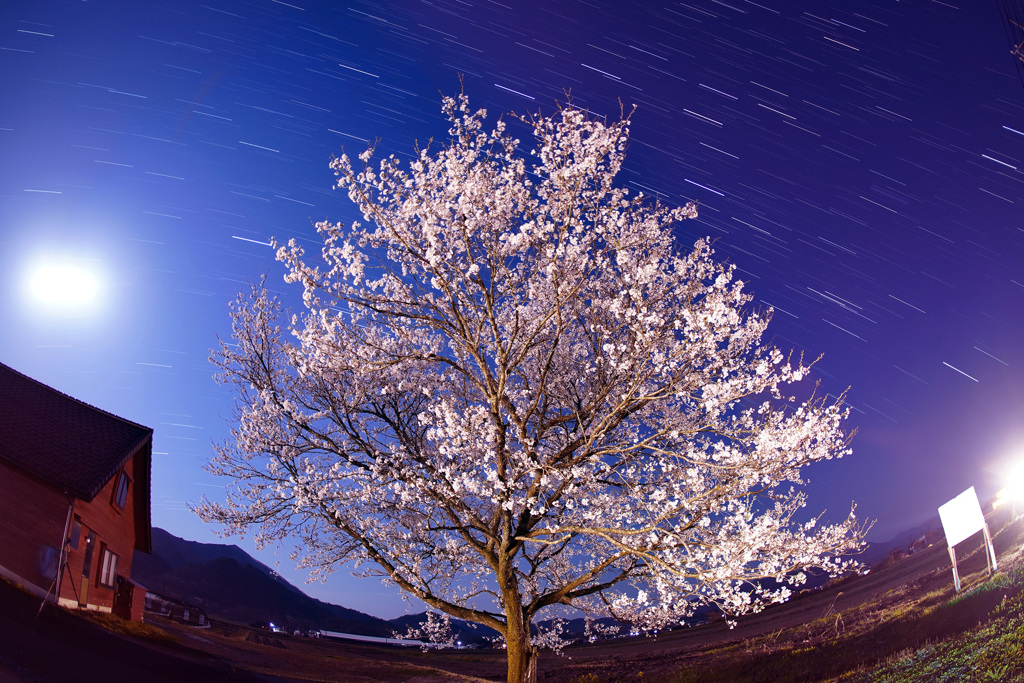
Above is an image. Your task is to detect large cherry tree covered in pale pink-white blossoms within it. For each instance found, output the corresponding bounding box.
[197,96,863,681]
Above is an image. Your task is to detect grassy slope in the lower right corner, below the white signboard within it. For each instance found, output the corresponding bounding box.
[667,520,1024,683]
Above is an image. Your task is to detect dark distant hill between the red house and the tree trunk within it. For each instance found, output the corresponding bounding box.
[132,528,389,637]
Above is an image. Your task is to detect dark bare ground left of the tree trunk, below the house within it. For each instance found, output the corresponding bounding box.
[0,580,483,683]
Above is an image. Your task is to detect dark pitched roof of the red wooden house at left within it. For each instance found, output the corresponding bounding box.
[0,364,153,501]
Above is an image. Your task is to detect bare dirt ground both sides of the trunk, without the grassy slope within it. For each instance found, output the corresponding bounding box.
[0,511,1024,683]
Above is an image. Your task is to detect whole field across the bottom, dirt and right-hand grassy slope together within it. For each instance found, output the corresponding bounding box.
[0,514,1024,683]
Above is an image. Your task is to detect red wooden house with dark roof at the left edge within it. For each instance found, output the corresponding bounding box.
[0,364,153,618]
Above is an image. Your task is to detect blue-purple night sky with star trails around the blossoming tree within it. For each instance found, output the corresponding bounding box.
[0,0,1024,616]
